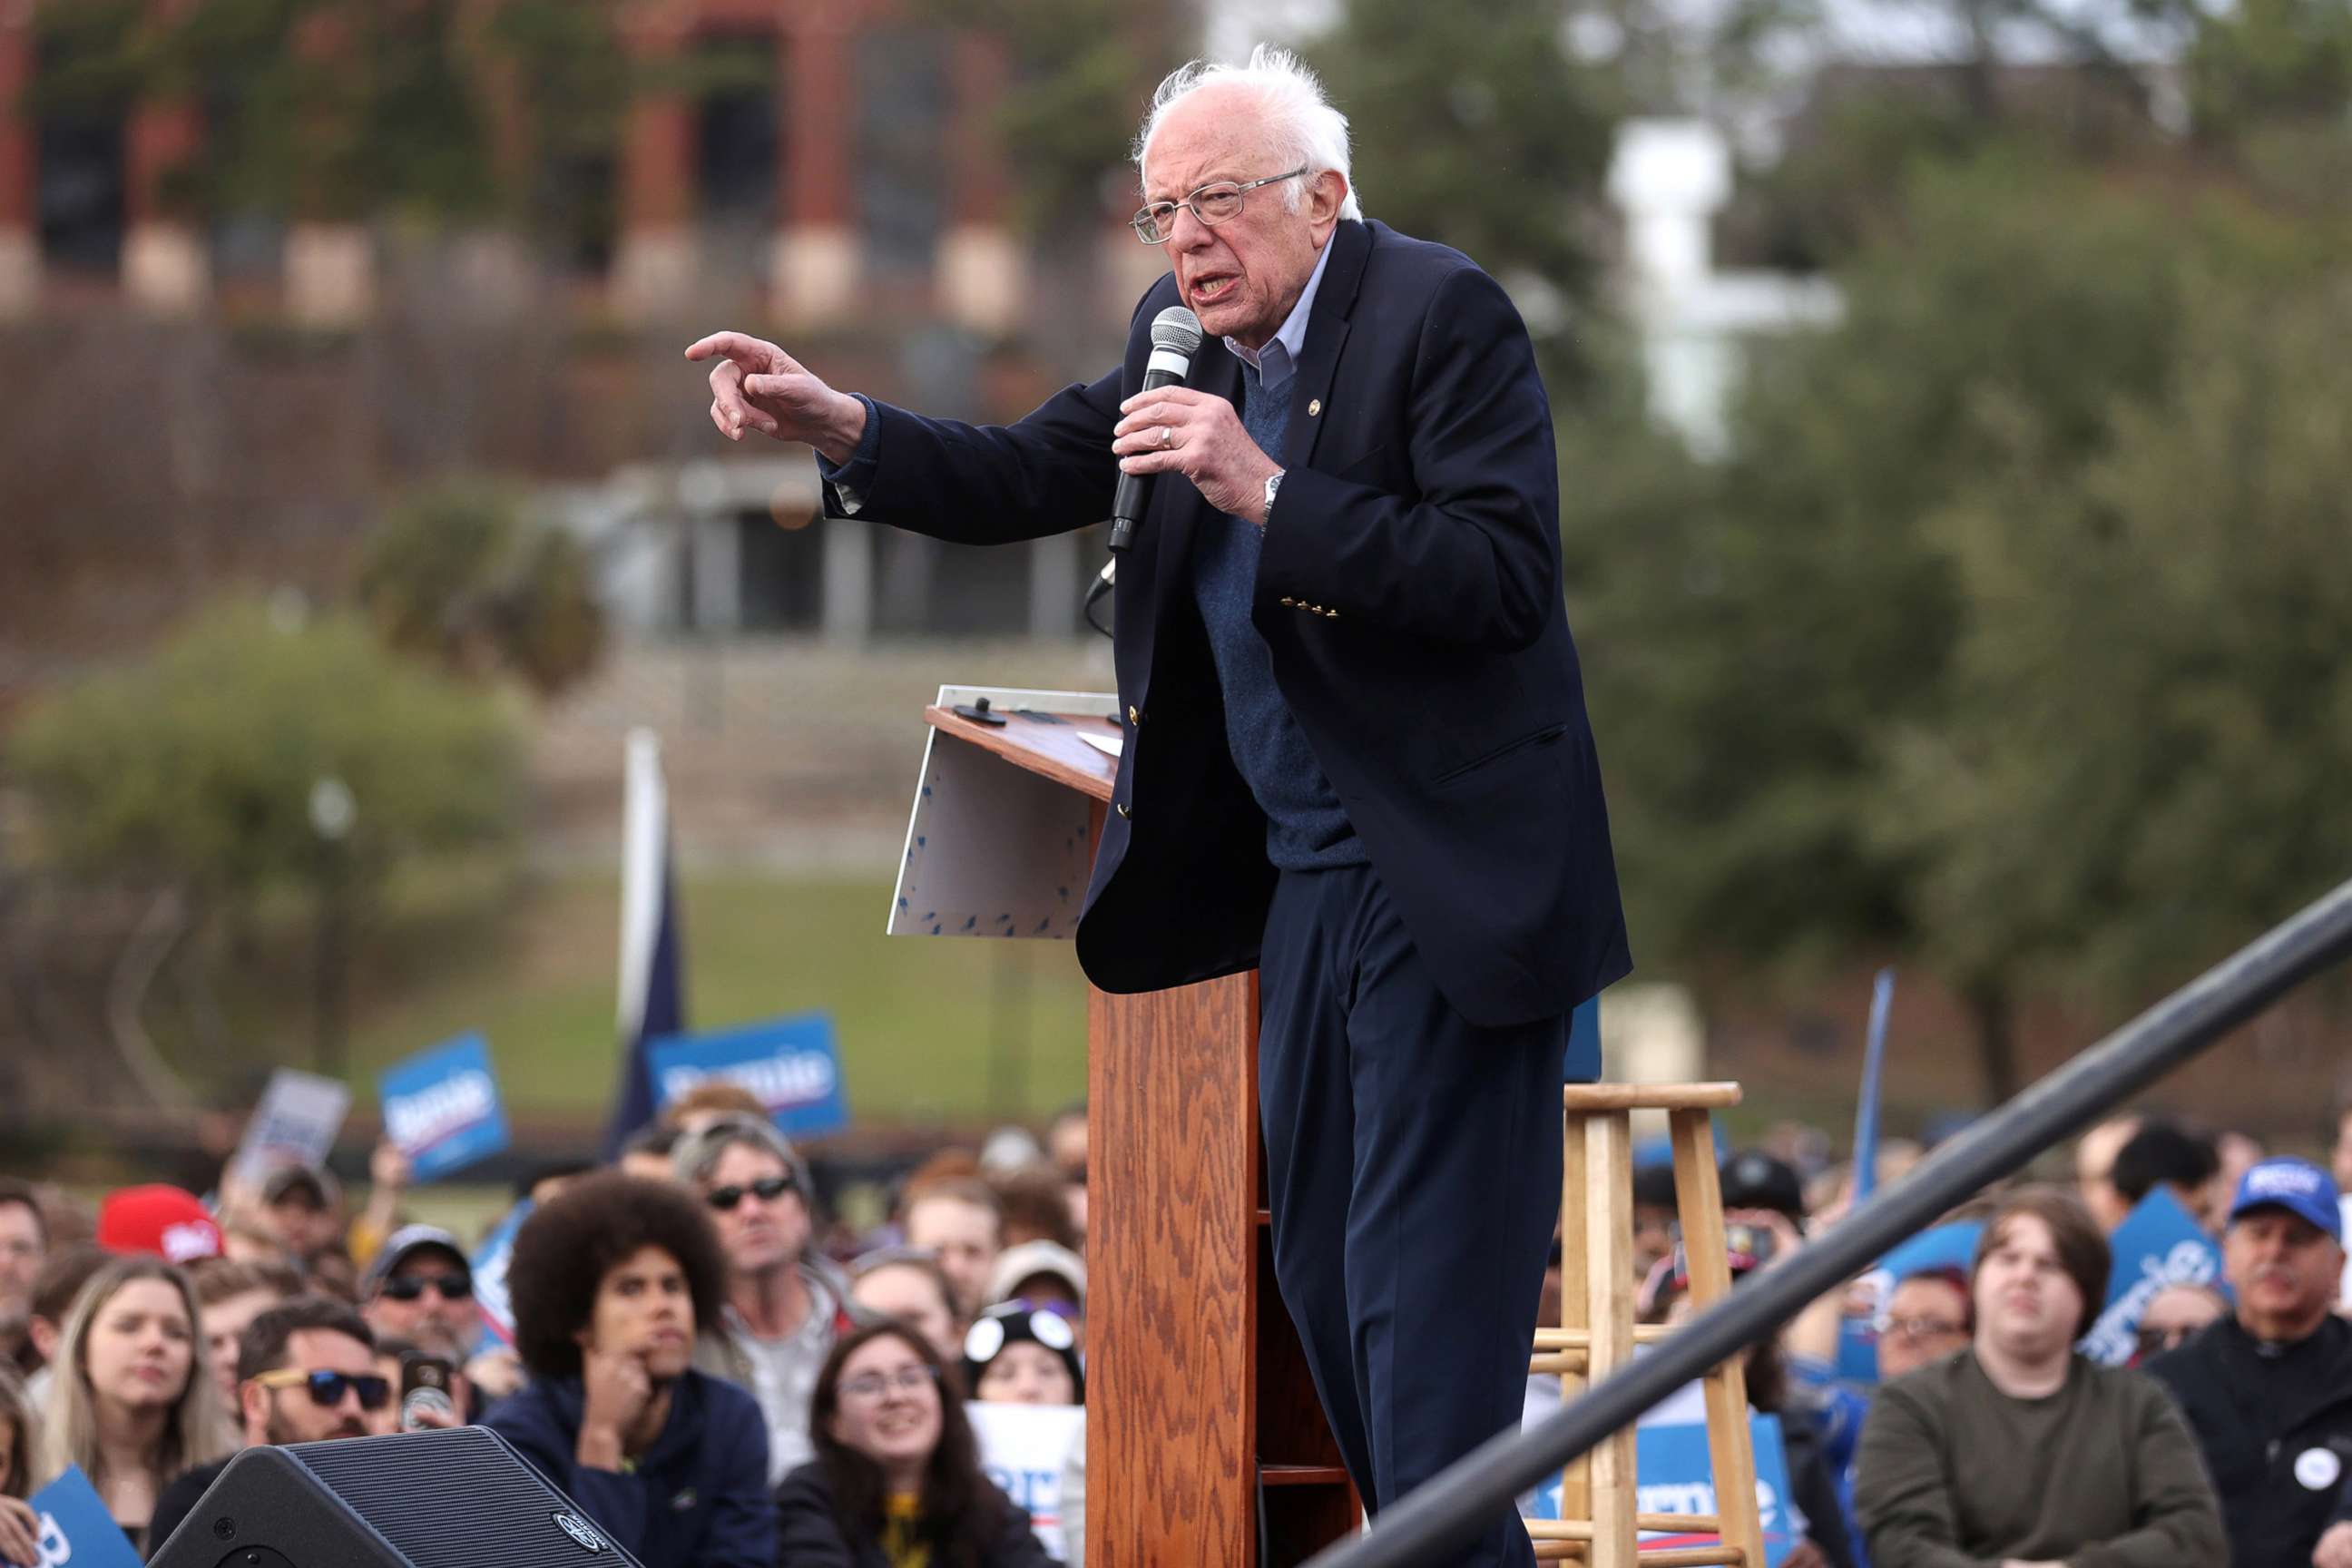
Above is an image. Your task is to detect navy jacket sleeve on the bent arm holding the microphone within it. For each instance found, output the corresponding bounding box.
[1259,266,1559,649]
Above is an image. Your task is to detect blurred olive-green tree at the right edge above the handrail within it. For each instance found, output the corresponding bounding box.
[1877,279,2352,996]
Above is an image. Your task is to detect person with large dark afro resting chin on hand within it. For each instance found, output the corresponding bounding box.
[485,1171,776,1568]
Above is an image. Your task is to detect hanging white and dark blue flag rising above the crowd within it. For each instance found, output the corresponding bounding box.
[604,729,687,1161]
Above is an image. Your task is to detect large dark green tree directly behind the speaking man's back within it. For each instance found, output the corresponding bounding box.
[1566,151,2326,1095]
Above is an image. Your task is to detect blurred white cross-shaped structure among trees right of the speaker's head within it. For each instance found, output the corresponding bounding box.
[1609,120,1844,456]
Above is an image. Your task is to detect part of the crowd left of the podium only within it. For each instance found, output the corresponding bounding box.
[0,1083,1087,1568]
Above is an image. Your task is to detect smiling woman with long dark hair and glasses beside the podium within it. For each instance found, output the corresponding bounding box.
[776,1318,1054,1568]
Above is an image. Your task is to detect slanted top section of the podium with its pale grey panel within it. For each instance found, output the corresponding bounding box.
[889,686,1117,940]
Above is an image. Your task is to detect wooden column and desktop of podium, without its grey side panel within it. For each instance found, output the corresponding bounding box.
[925,708,1362,1568]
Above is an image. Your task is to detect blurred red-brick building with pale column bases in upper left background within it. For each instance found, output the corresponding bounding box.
[0,0,1161,336]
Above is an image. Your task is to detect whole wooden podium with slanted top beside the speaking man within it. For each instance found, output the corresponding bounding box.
[891,686,1362,1568]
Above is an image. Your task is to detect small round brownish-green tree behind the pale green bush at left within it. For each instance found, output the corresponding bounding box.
[358,480,604,696]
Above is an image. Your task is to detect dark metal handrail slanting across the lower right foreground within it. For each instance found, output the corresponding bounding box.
[1308,882,2352,1568]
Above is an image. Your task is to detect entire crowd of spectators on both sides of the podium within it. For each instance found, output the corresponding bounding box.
[0,1086,2352,1568]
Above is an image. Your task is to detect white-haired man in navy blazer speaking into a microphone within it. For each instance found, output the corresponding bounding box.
[687,49,1630,1563]
